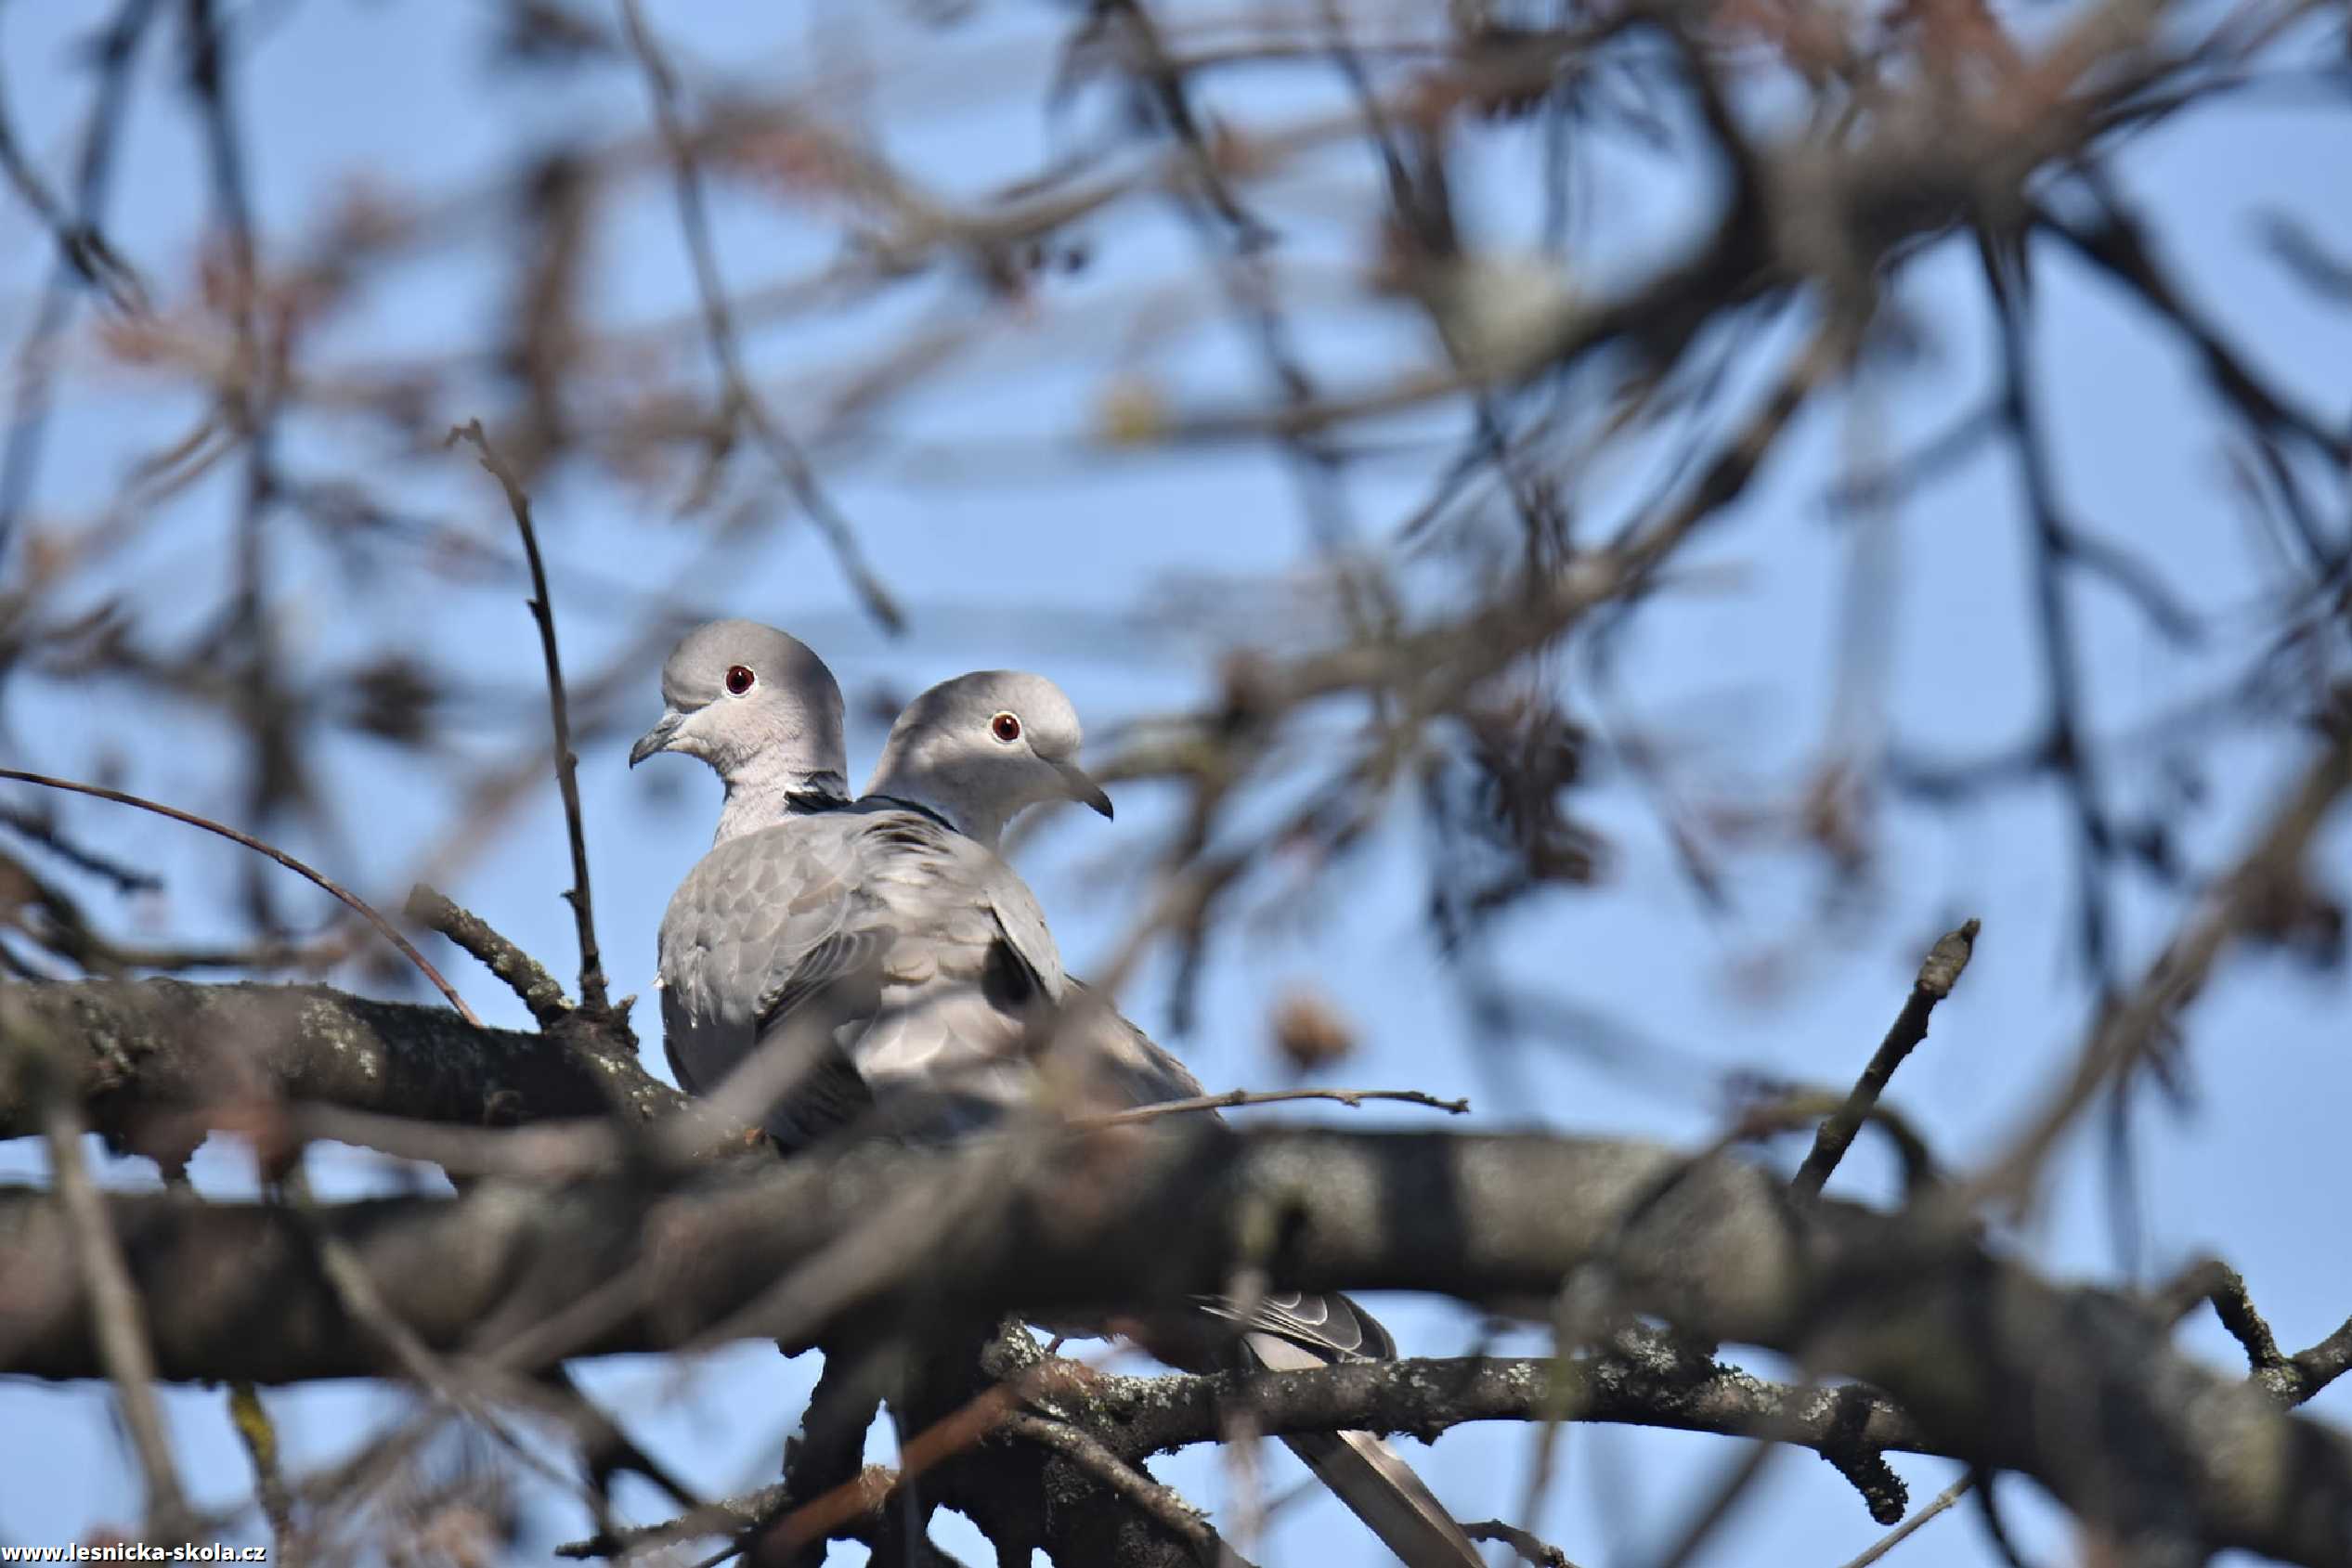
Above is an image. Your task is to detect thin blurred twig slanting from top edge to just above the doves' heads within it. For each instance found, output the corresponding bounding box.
[621,0,905,632]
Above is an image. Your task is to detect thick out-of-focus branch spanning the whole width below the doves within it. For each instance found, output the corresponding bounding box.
[0,1128,2352,1565]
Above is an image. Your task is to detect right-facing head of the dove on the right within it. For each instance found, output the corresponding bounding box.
[865,670,1111,847]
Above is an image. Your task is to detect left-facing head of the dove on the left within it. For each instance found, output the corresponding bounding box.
[628,621,849,801]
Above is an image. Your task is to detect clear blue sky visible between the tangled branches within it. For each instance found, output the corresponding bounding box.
[0,0,2352,1568]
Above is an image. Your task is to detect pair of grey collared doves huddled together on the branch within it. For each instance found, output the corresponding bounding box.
[628,621,1479,1568]
